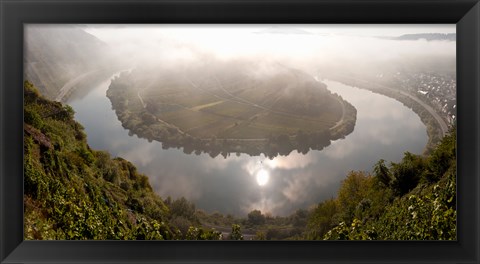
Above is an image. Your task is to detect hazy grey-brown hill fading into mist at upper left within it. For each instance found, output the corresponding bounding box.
[24,25,112,99]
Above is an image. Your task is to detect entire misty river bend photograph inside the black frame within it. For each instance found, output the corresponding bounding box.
[23,23,458,240]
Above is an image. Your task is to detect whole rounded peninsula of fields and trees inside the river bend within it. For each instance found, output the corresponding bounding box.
[107,63,356,155]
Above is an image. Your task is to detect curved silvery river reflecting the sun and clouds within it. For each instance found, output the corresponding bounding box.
[67,72,427,216]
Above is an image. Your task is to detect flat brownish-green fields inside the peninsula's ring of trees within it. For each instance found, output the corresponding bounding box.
[139,70,342,139]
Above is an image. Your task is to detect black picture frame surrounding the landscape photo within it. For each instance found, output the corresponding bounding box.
[0,0,480,263]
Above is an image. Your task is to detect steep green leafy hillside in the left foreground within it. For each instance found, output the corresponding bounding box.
[24,82,220,240]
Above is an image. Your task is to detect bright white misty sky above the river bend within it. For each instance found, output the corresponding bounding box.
[79,24,456,78]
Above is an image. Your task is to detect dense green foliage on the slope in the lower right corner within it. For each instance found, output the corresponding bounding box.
[306,128,457,240]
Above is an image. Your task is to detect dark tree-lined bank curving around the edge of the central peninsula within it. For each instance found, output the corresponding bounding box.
[107,70,356,158]
